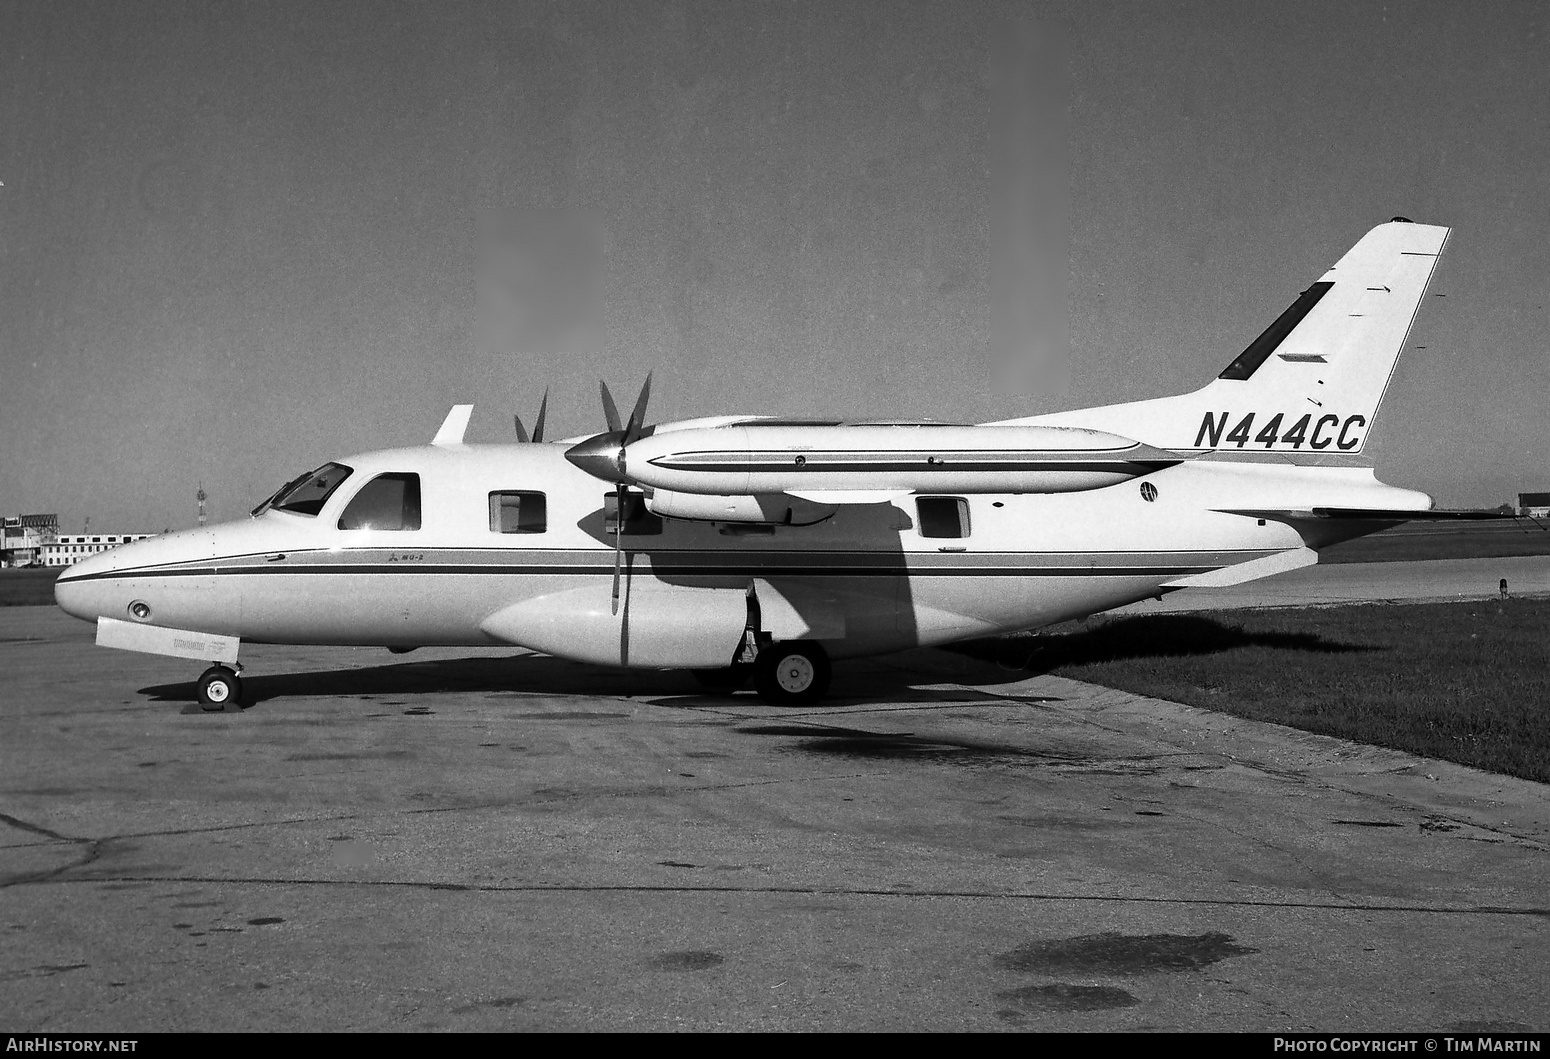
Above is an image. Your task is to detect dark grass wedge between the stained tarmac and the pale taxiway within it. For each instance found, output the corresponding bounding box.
[966,600,1550,783]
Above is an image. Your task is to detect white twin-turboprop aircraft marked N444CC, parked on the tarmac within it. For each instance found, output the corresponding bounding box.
[54,219,1488,709]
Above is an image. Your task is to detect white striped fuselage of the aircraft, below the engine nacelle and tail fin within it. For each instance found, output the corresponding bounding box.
[56,445,1429,667]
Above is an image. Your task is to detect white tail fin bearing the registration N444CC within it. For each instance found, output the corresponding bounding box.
[1014,219,1448,456]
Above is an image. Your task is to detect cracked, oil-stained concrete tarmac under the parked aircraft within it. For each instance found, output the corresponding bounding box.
[0,608,1550,1034]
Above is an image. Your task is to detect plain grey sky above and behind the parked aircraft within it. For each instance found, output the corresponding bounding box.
[0,0,1550,532]
